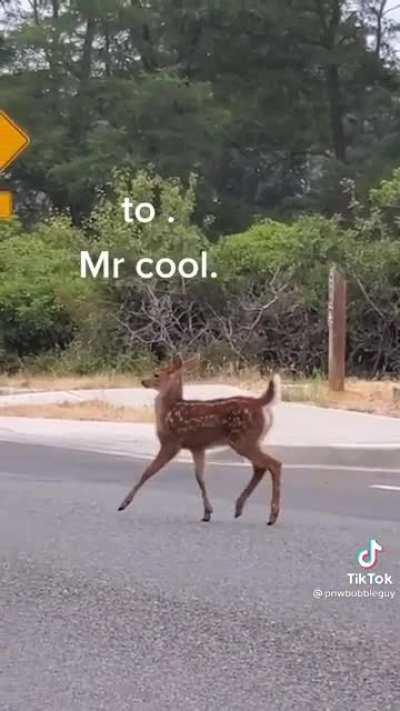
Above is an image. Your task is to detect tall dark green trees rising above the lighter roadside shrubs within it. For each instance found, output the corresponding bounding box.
[0,0,400,231]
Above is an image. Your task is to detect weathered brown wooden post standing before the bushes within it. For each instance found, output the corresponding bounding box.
[328,267,347,391]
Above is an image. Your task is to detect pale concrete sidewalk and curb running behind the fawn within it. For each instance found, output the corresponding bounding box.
[0,385,400,472]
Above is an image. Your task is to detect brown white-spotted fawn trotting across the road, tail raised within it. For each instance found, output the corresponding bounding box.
[118,356,282,525]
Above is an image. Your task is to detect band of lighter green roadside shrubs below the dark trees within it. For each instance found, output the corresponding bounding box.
[0,170,400,378]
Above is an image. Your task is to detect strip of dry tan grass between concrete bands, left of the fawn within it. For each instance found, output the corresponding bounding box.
[0,400,154,422]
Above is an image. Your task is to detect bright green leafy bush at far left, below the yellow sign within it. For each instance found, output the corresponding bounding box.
[0,218,90,367]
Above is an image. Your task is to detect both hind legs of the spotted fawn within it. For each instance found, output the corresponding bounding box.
[229,441,282,526]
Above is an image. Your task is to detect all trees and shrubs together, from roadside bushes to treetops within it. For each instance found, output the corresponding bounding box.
[0,0,400,390]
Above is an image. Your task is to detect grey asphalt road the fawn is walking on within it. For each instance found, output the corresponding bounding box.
[0,444,400,711]
